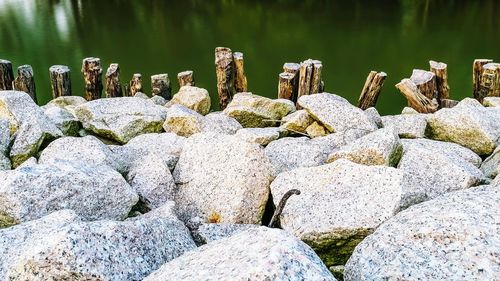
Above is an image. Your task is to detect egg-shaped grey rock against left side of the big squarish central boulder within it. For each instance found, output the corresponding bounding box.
[127,153,175,209]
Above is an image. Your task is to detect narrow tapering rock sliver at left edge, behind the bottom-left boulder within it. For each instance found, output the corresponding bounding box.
[0,210,80,280]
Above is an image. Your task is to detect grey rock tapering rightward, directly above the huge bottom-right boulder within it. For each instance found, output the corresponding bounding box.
[398,142,485,208]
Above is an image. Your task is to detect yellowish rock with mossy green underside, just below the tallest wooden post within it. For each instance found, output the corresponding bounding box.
[224,93,295,128]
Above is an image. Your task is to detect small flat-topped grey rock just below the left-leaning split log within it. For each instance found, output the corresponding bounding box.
[382,113,427,139]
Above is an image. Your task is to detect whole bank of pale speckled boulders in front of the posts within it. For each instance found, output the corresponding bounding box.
[0,86,500,281]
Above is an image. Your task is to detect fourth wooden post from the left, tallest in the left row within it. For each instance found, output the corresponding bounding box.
[82,57,103,101]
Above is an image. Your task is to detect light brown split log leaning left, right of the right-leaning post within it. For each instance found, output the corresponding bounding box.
[396,79,438,113]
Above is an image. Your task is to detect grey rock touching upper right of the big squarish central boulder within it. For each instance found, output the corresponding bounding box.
[265,137,330,174]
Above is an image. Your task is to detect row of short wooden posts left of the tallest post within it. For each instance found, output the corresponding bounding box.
[0,57,199,102]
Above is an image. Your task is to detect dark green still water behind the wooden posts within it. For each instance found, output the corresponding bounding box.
[0,0,500,114]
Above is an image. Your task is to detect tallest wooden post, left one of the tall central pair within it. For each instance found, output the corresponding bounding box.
[215,47,234,110]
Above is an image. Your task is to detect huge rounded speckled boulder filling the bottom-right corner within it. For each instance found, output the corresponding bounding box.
[344,186,500,281]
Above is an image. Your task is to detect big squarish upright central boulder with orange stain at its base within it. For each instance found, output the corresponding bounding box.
[173,133,274,224]
